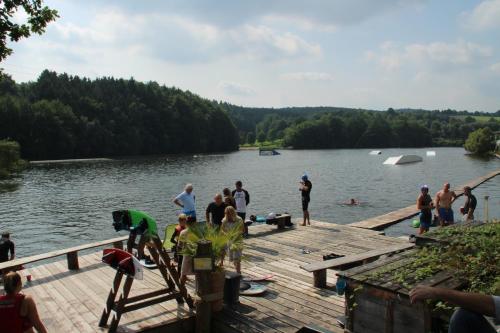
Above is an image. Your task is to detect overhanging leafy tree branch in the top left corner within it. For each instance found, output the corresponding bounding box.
[0,0,59,62]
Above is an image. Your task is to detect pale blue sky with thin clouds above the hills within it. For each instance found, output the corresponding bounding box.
[0,0,500,112]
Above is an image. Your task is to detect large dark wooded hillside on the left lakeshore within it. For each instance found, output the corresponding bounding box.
[0,70,238,159]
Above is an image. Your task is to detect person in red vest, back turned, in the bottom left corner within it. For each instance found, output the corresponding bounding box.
[0,272,47,333]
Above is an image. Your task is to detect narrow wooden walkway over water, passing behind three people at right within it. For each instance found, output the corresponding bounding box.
[349,169,500,230]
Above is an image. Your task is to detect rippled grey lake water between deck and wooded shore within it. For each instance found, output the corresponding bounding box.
[0,148,500,256]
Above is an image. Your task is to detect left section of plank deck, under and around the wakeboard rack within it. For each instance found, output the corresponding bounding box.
[10,252,194,332]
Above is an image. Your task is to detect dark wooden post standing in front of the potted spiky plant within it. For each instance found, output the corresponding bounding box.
[195,240,212,333]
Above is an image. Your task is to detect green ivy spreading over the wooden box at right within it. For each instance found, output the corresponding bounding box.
[370,221,500,295]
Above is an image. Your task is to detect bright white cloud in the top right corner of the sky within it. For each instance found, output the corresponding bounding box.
[462,0,500,30]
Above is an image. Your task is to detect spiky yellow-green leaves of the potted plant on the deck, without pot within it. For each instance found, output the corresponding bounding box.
[181,223,243,269]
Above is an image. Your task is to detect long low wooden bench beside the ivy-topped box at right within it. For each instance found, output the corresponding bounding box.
[300,243,415,288]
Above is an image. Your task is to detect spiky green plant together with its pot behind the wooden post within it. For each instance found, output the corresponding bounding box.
[182,223,243,312]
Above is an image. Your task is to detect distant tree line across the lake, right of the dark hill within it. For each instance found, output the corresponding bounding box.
[223,103,500,149]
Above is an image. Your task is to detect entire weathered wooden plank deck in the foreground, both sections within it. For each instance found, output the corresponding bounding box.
[3,221,405,332]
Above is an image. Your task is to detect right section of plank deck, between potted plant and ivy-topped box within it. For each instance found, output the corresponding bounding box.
[209,221,407,332]
